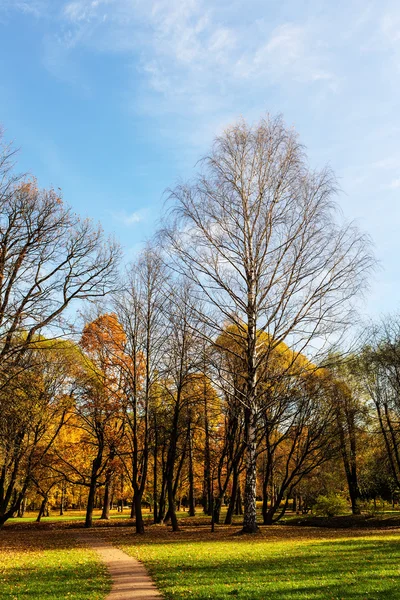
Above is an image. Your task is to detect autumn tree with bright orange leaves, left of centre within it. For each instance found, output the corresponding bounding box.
[53,313,125,527]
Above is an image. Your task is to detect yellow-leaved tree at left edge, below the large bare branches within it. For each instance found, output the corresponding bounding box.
[0,339,74,526]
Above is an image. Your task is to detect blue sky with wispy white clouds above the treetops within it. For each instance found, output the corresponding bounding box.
[0,0,400,316]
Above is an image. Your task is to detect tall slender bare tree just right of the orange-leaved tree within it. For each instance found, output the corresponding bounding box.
[114,246,167,533]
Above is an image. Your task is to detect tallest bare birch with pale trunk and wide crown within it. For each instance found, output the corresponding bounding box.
[163,117,372,533]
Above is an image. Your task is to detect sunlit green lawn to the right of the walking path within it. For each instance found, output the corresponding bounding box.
[119,532,400,600]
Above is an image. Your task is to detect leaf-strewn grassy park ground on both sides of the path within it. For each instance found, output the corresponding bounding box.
[0,514,400,600]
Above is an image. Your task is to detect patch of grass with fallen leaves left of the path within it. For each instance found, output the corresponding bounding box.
[0,530,111,600]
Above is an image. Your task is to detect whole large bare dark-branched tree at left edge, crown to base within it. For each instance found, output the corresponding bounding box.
[0,135,120,520]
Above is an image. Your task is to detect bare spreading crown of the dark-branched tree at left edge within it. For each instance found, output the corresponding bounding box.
[0,138,120,385]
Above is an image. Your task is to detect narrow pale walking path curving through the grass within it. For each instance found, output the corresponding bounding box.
[81,535,162,600]
